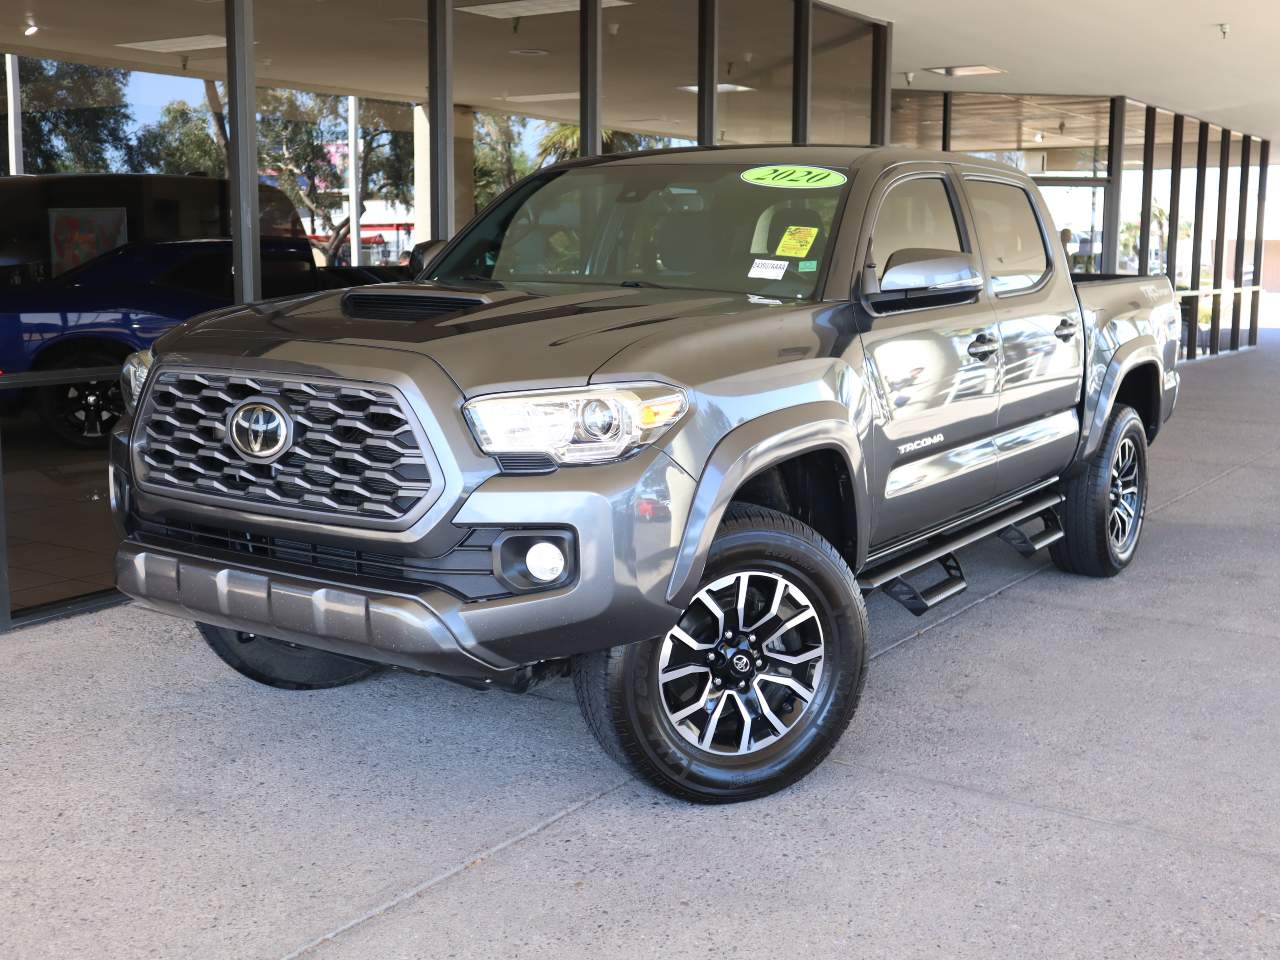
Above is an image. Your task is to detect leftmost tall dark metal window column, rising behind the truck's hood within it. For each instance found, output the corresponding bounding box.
[225,0,262,303]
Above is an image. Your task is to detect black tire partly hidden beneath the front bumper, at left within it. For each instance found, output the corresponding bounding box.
[196,623,383,690]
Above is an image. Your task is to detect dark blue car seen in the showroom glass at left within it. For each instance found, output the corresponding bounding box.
[0,237,407,447]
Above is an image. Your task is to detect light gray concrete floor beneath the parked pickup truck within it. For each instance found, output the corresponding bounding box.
[0,332,1280,960]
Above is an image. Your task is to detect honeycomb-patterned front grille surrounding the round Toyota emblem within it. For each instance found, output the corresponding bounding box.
[134,369,431,524]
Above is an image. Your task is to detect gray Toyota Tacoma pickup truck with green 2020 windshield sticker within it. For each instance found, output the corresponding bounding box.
[111,146,1180,803]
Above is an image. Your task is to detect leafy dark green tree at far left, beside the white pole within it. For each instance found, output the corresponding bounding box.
[4,56,133,173]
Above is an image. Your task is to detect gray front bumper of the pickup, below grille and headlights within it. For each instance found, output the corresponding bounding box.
[115,442,695,686]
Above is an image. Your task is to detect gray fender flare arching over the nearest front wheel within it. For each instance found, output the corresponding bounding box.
[667,401,870,607]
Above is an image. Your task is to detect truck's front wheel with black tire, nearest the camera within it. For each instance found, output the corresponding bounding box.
[573,504,868,804]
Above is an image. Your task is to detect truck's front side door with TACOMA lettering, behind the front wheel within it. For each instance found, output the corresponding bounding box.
[855,164,1001,548]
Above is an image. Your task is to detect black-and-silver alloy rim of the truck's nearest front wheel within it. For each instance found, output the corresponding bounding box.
[658,570,826,756]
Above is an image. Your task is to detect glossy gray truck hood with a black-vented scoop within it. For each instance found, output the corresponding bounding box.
[157,283,752,397]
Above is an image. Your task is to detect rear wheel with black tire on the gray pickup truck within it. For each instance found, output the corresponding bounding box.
[1050,406,1147,577]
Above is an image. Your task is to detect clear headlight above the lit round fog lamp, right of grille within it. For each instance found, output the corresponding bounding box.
[462,383,689,463]
